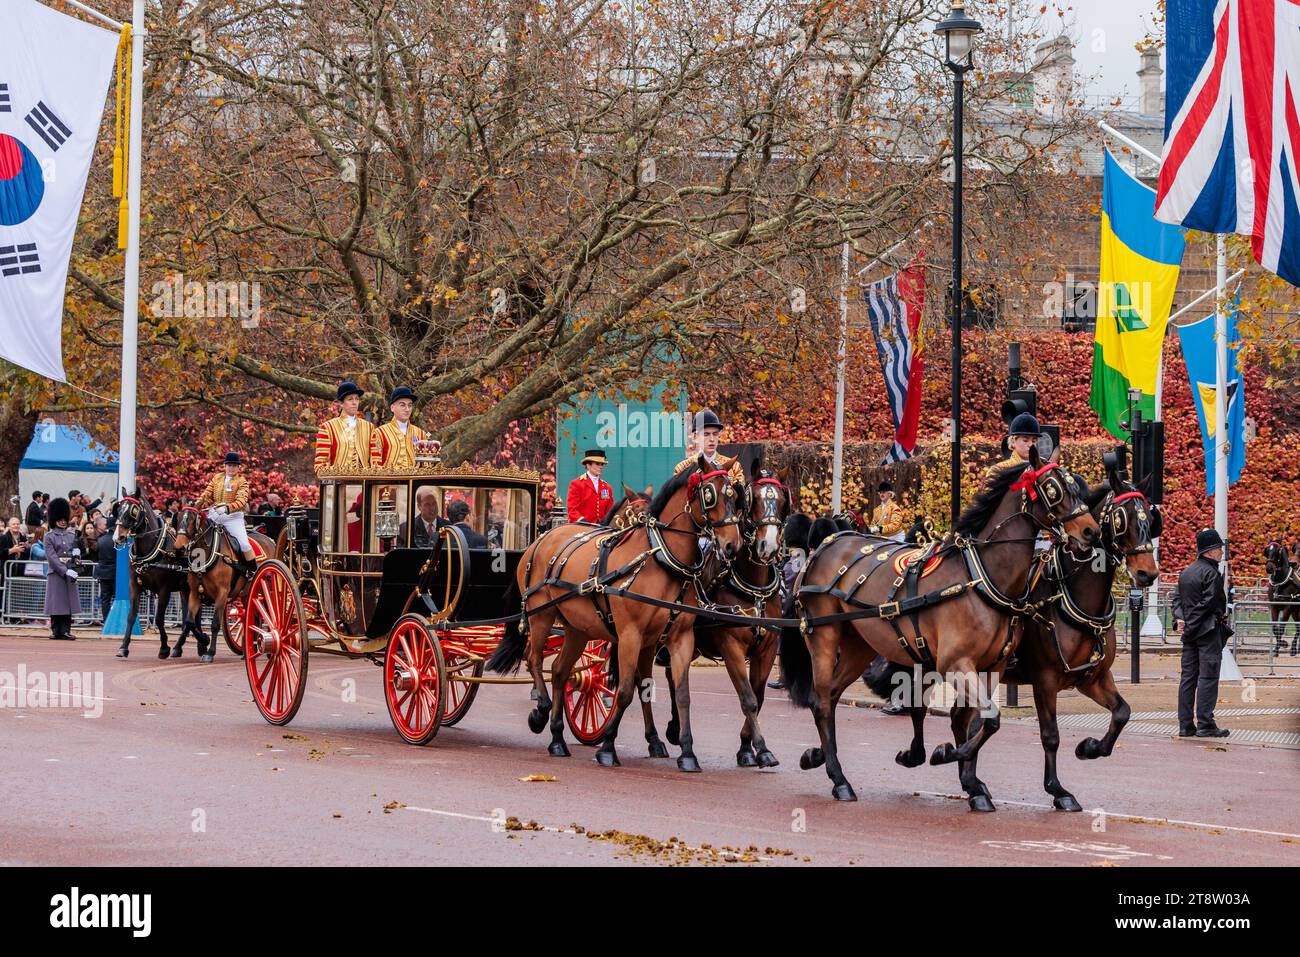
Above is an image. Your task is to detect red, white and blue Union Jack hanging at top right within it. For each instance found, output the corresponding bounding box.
[1156,0,1300,286]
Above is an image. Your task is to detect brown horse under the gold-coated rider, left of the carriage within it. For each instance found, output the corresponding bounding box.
[176,503,276,662]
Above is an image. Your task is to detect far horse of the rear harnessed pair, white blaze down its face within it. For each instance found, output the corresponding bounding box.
[660,463,792,767]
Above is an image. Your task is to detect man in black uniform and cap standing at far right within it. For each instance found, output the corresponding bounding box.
[1174,528,1232,737]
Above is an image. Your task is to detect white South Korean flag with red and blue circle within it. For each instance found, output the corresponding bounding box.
[0,0,117,381]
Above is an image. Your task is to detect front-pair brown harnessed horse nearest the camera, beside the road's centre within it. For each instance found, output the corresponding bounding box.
[781,449,1100,810]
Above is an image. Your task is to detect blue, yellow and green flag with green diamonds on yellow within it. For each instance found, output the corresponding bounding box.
[1088,151,1183,439]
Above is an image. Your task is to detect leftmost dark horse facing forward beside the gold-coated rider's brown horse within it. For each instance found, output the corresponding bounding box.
[113,489,205,658]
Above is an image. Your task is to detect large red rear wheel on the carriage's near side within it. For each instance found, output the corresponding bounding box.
[243,562,307,724]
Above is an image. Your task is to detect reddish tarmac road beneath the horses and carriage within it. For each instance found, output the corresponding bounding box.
[0,637,1300,866]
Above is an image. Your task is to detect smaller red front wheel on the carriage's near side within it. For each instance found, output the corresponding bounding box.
[384,615,447,745]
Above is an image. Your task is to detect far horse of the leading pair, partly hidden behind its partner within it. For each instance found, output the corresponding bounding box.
[871,471,1164,811]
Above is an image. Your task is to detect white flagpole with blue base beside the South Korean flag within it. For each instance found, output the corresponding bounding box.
[104,0,144,635]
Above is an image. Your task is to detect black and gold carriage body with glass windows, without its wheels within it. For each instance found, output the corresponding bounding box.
[306,467,540,654]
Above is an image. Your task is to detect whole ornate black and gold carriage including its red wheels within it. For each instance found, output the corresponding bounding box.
[241,463,614,745]
